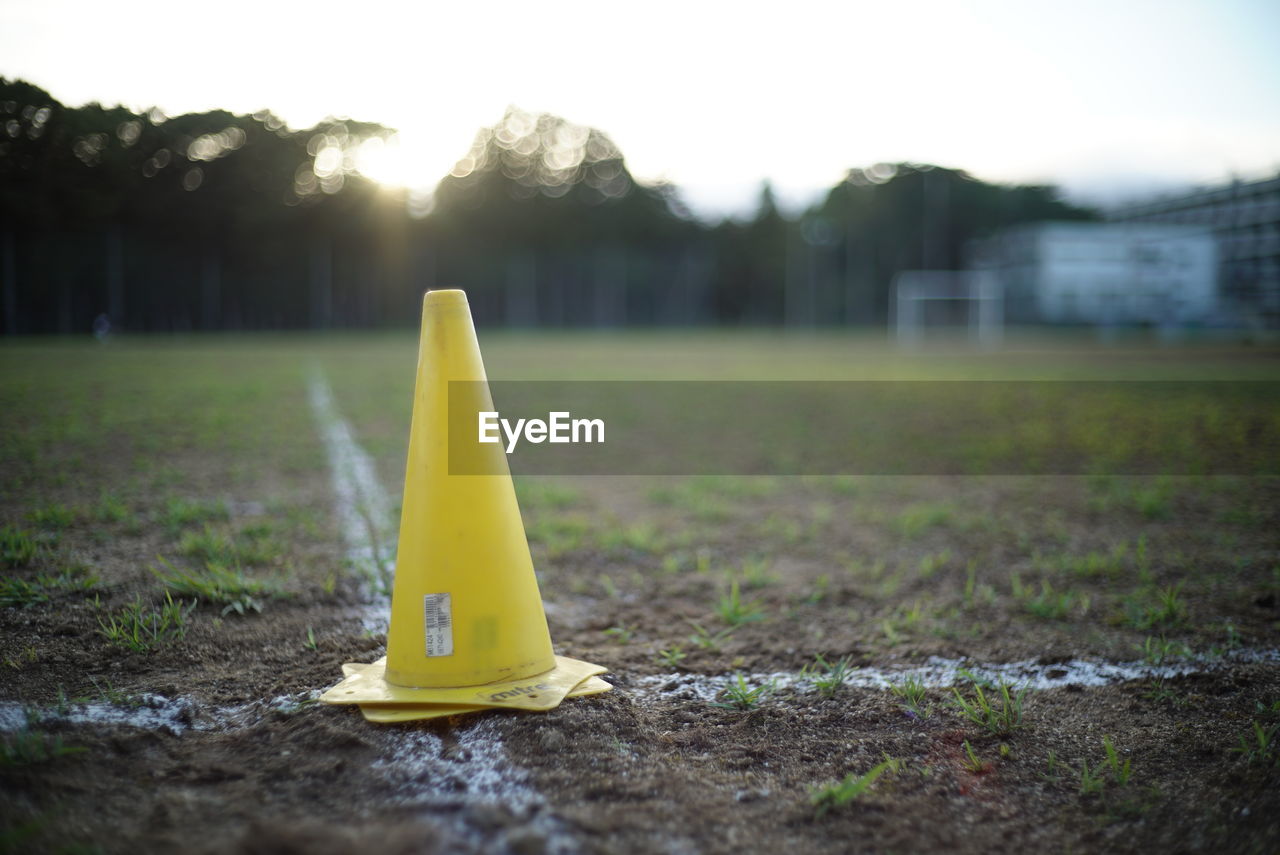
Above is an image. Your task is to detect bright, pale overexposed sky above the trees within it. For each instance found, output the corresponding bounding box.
[0,0,1280,216]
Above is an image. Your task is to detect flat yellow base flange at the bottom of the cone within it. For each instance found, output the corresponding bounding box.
[320,657,608,712]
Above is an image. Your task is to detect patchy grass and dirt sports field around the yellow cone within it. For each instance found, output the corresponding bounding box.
[0,332,1280,854]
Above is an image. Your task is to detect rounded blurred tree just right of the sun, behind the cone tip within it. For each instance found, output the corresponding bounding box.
[431,108,699,325]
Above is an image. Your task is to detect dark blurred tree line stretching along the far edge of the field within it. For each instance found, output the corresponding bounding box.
[0,78,1094,334]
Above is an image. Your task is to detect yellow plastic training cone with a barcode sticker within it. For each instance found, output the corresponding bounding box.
[321,291,608,721]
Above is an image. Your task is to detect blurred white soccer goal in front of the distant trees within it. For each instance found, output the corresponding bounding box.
[892,270,1005,347]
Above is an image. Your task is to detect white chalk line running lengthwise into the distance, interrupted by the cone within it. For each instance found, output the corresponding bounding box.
[307,369,576,854]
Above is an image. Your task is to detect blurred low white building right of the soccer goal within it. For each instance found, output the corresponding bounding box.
[973,223,1221,326]
